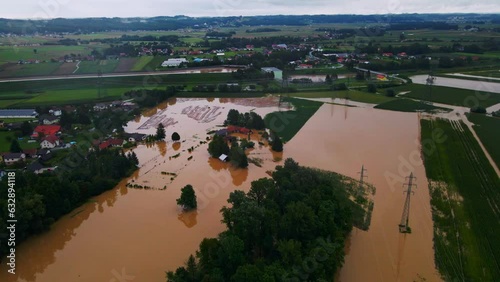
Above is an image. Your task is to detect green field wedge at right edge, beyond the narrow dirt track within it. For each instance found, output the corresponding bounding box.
[467,113,500,167]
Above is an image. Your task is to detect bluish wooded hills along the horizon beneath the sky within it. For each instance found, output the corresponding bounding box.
[0,14,500,34]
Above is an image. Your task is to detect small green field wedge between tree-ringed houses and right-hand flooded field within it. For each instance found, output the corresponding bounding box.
[264,98,323,142]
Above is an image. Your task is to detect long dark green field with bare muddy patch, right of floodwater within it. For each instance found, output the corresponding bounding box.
[421,119,500,281]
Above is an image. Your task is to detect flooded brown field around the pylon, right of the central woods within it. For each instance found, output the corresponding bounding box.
[285,104,440,282]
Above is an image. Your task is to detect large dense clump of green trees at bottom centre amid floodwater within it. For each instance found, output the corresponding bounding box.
[167,159,372,282]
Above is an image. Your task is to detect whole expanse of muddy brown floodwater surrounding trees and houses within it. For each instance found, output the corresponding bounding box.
[0,98,439,282]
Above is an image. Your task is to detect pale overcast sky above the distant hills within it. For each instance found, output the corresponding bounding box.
[0,0,500,18]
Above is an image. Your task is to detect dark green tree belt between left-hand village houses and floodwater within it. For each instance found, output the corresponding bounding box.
[0,149,138,258]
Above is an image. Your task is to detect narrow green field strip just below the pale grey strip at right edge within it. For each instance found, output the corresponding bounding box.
[400,84,500,108]
